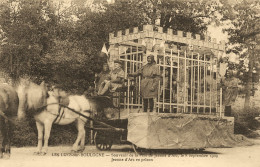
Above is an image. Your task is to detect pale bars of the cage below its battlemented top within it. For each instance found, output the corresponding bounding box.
[110,29,222,117]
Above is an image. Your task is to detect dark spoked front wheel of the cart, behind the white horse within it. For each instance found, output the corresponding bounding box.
[94,131,113,151]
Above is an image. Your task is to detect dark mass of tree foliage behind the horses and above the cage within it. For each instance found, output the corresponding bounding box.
[0,0,223,93]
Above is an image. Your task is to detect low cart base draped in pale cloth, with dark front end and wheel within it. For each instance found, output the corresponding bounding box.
[87,113,234,152]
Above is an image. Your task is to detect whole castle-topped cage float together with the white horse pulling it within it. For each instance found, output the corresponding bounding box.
[14,25,248,155]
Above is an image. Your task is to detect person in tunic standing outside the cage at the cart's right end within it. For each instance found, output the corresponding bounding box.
[222,70,239,116]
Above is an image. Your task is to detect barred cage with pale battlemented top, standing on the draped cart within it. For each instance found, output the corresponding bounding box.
[109,25,225,116]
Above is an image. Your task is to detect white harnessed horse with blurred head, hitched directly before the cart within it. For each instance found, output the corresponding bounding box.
[17,81,112,155]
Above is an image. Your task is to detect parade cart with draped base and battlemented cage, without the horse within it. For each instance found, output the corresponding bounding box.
[85,25,242,153]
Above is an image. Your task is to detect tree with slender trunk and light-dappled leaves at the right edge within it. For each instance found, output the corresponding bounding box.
[222,0,260,110]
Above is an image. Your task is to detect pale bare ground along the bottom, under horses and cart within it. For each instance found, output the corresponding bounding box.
[0,138,260,167]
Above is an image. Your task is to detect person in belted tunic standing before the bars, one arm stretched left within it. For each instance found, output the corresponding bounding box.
[128,54,161,112]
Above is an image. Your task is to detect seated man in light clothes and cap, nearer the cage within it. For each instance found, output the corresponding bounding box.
[98,60,124,96]
